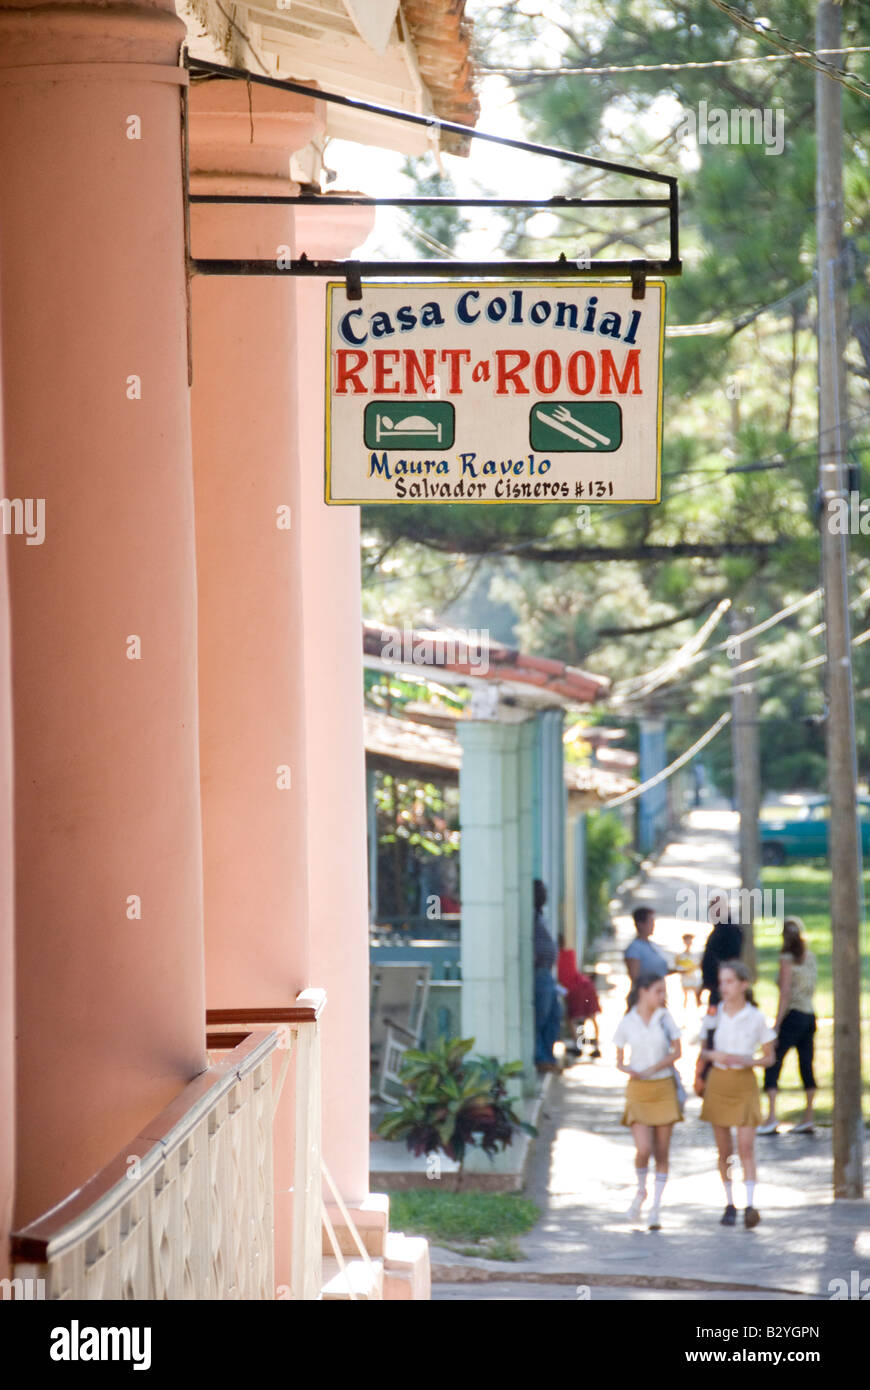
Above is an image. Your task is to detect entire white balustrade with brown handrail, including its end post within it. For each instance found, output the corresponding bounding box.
[13,990,327,1300]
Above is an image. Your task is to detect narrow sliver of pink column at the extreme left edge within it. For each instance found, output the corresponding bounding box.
[0,353,13,1279]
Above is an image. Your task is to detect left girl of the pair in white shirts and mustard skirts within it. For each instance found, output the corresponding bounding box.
[613,972,682,1230]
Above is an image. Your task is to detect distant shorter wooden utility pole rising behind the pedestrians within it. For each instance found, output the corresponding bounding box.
[728,610,762,979]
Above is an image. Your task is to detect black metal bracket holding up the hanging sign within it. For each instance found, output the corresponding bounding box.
[182,49,682,284]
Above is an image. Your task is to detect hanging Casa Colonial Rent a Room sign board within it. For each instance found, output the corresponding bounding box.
[327,279,664,503]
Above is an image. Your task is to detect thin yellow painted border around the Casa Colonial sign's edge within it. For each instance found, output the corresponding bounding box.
[324,277,667,507]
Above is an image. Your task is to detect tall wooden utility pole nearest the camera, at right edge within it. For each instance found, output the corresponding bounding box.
[816,0,864,1197]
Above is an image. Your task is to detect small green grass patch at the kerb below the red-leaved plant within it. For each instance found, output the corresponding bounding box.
[389,1187,541,1259]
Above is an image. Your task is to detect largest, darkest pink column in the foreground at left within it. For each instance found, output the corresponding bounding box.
[0,0,206,1223]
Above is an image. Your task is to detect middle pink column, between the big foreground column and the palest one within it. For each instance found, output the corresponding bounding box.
[190,81,326,1284]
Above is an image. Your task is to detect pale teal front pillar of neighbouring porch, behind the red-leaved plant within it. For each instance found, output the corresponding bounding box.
[457,720,521,1062]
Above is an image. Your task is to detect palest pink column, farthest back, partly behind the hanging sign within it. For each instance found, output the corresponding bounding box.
[295,199,374,1202]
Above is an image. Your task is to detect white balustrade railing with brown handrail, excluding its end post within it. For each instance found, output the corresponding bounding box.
[13,1027,279,1300]
